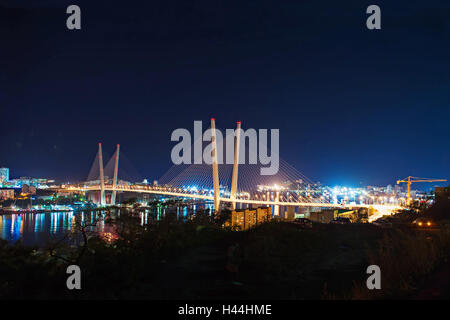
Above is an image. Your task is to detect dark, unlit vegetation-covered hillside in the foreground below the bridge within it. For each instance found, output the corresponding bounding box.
[0,196,450,299]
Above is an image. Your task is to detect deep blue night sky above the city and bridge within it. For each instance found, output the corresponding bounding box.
[0,0,450,187]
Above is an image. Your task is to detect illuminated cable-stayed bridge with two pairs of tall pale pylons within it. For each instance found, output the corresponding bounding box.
[59,119,401,215]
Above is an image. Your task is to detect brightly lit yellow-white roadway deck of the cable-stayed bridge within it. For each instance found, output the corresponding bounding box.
[58,185,402,213]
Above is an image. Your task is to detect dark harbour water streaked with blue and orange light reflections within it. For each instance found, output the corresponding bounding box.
[0,204,213,246]
